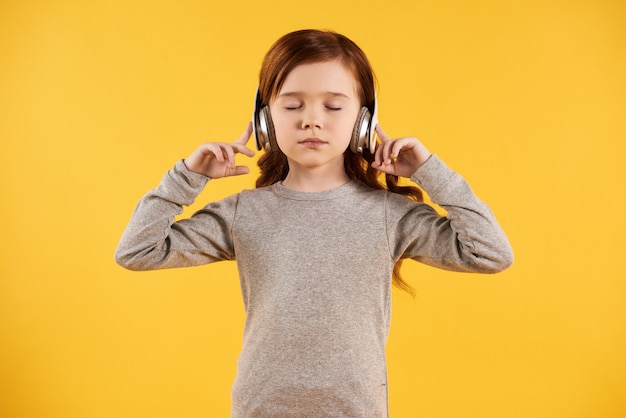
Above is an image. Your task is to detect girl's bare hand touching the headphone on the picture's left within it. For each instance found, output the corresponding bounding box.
[184,123,254,179]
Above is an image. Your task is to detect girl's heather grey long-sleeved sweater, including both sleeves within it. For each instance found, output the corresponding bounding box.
[116,156,513,418]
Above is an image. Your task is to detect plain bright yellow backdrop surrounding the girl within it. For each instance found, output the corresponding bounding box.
[0,0,626,418]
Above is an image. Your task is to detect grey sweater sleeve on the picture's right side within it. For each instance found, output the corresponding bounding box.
[387,155,513,273]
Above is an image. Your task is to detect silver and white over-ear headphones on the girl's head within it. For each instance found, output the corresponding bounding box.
[252,89,378,154]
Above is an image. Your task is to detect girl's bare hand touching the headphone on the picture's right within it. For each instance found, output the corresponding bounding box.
[372,125,430,177]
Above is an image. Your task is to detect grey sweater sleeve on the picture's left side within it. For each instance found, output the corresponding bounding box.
[115,160,238,270]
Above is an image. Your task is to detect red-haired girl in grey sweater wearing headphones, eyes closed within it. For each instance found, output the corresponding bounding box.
[116,30,512,417]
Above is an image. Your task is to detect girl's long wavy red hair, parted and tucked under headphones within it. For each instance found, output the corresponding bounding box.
[256,29,423,294]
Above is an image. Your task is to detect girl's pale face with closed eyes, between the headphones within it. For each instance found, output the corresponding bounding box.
[270,61,361,171]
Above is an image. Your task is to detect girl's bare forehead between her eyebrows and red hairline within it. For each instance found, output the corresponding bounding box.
[278,61,358,97]
